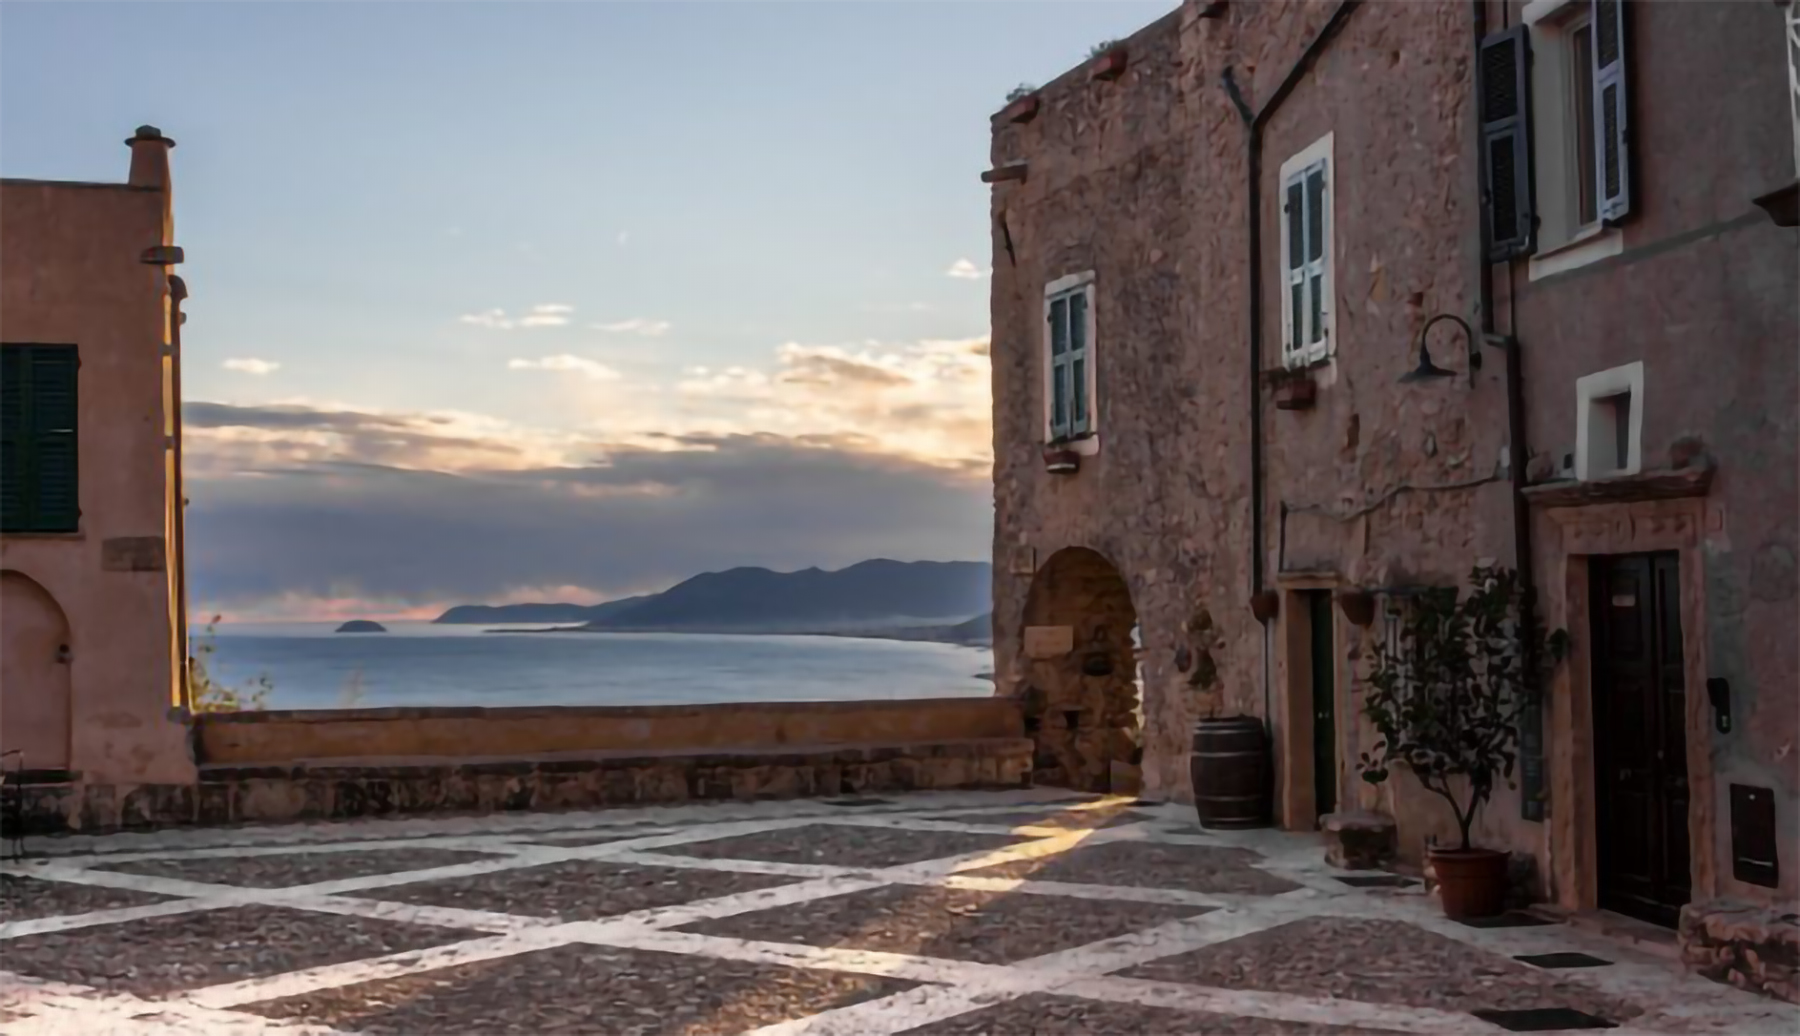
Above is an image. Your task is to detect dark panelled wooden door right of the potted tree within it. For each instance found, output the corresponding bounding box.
[1591,554,1692,926]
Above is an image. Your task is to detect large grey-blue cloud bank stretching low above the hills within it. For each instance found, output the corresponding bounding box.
[187,403,992,615]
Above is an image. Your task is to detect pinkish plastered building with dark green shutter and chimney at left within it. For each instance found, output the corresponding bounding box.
[0,126,194,800]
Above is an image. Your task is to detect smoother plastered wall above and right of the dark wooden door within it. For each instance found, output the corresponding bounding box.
[1514,4,1800,903]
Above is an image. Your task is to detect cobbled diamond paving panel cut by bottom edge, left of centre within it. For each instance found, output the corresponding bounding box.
[239,946,914,1036]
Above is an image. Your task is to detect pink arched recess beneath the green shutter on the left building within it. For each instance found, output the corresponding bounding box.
[0,570,72,770]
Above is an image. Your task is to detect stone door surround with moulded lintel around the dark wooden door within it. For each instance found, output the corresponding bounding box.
[1544,496,1724,912]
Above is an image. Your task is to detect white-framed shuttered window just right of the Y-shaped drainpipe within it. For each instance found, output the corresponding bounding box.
[1282,133,1334,367]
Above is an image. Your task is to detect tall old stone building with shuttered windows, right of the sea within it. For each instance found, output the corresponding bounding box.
[985,0,1800,956]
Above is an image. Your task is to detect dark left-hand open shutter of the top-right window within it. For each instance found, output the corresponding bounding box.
[1476,24,1533,263]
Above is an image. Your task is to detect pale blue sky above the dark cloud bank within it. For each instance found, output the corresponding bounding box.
[0,0,1174,615]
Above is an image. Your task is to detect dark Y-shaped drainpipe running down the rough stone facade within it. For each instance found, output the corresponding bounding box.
[1220,0,1361,736]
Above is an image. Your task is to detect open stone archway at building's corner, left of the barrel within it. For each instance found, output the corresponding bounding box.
[1021,547,1143,793]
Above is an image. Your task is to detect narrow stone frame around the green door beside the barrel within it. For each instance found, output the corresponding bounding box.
[1274,572,1355,831]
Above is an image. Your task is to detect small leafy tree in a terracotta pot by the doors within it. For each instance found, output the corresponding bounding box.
[1359,567,1568,917]
